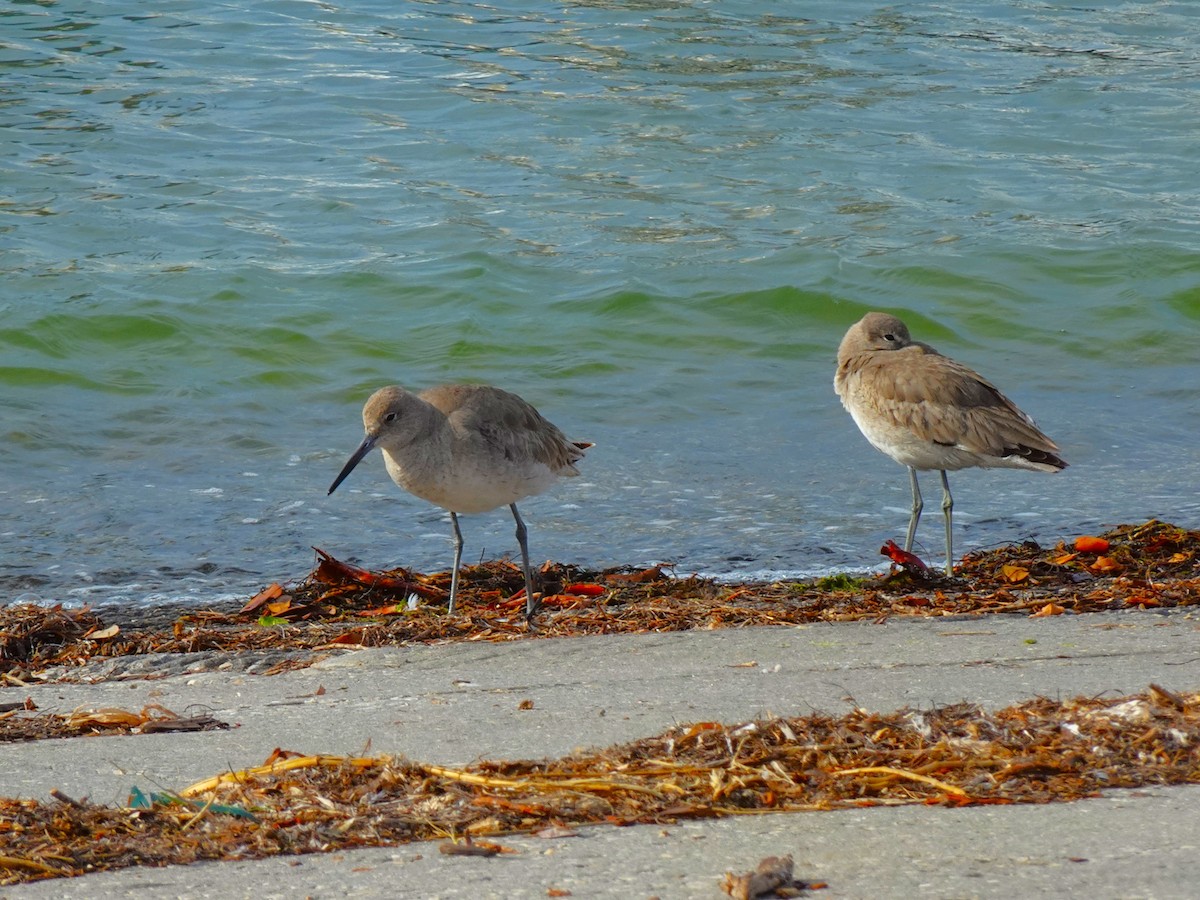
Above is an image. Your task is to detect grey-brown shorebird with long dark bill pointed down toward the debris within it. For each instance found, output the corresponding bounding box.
[329,384,592,620]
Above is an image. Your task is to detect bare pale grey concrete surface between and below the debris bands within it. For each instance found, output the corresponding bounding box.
[0,611,1200,898]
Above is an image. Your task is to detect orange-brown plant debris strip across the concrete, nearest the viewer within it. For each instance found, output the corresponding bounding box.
[0,685,1200,895]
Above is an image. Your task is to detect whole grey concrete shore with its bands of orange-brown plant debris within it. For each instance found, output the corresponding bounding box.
[0,522,1200,898]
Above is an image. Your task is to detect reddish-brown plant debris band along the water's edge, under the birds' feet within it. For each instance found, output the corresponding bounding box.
[0,521,1200,686]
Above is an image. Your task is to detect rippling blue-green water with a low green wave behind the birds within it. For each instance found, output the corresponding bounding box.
[0,0,1200,604]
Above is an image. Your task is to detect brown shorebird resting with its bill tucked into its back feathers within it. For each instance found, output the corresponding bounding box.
[833,312,1067,576]
